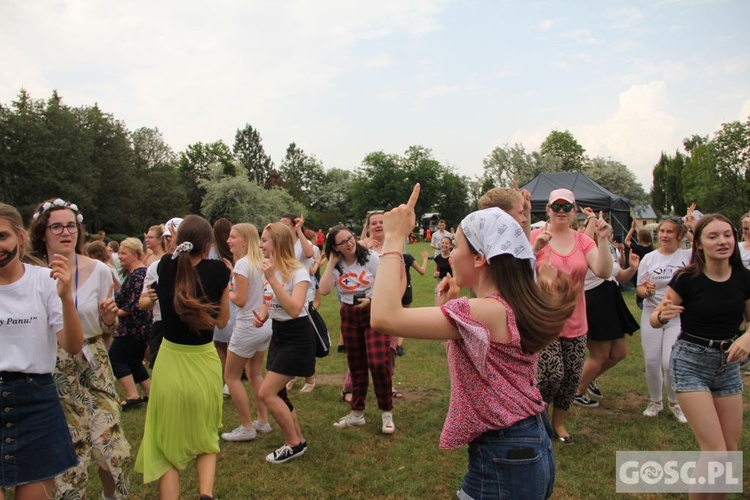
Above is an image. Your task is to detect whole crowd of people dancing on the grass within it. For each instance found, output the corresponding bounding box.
[0,184,750,500]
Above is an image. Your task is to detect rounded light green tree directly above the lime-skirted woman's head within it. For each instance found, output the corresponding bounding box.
[178,141,237,213]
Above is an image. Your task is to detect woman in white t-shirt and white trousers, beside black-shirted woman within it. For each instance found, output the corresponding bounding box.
[636,216,690,424]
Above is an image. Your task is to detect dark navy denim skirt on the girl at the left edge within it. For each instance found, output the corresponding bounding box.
[0,373,78,488]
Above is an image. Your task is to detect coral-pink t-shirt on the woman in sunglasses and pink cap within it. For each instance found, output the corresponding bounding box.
[529,229,596,339]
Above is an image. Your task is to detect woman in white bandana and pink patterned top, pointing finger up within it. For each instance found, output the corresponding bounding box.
[370,184,580,499]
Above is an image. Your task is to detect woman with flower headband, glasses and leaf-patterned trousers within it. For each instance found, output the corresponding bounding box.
[29,198,130,498]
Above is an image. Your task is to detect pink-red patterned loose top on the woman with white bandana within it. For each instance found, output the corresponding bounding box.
[440,297,545,450]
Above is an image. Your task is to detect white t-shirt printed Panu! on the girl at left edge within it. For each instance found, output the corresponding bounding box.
[0,264,63,373]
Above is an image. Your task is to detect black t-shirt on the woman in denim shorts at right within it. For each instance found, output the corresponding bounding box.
[669,266,750,340]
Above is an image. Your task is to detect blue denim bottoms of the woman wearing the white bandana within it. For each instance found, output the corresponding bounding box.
[458,415,555,500]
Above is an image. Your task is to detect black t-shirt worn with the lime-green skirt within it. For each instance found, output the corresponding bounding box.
[156,255,230,345]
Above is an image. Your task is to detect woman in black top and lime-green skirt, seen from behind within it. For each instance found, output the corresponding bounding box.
[135,215,230,499]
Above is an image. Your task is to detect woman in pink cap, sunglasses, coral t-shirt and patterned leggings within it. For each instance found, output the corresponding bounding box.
[531,189,612,443]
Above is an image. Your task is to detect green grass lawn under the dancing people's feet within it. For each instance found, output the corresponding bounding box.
[82,240,750,499]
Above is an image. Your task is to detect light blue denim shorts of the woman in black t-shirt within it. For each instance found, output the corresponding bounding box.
[669,339,742,397]
